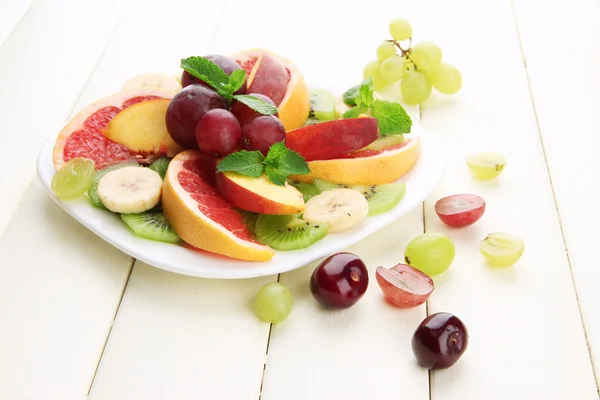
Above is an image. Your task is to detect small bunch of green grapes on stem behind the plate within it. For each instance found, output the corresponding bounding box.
[363,18,462,104]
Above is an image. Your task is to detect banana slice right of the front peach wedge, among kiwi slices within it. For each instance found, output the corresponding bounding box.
[302,188,369,233]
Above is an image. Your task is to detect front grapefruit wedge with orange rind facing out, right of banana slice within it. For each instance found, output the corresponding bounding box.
[162,150,275,261]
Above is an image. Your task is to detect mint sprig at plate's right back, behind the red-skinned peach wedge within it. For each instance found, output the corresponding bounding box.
[343,78,412,136]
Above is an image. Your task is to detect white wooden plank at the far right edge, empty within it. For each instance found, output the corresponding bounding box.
[514,0,600,382]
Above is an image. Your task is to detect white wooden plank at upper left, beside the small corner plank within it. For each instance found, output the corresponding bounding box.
[0,0,122,236]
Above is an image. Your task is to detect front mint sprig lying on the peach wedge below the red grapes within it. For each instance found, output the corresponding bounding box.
[217,141,310,186]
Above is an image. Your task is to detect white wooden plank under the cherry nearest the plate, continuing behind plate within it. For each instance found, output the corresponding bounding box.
[262,1,429,400]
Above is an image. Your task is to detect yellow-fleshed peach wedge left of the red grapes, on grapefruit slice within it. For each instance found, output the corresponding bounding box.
[103,99,183,157]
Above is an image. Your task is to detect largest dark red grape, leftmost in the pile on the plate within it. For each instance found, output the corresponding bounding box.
[165,85,226,149]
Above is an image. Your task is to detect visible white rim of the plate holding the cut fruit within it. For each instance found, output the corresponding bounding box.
[37,124,445,279]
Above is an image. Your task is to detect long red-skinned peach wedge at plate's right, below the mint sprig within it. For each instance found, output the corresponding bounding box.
[285,117,379,161]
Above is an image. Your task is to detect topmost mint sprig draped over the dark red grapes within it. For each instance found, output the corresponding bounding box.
[180,56,277,115]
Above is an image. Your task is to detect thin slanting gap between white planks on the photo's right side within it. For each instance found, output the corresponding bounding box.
[508,0,600,392]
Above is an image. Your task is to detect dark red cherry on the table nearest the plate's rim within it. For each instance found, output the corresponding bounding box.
[310,252,369,309]
